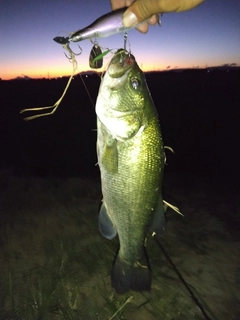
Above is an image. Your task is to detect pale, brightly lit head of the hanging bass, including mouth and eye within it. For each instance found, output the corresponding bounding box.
[96,49,150,140]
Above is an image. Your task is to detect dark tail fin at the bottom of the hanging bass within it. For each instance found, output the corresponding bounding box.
[112,251,151,294]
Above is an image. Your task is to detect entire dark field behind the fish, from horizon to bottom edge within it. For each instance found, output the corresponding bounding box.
[0,70,240,320]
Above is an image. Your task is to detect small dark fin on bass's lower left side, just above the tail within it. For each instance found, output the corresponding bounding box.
[98,203,117,240]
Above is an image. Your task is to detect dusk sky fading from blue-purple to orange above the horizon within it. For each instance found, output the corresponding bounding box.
[0,0,240,80]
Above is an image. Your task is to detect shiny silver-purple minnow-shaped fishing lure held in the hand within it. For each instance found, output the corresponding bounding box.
[53,7,149,44]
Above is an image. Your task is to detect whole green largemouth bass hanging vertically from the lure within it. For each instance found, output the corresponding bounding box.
[96,49,165,294]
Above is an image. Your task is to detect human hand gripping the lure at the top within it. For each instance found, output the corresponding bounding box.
[110,0,204,33]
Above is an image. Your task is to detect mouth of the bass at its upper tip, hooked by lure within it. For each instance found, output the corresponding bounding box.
[108,49,135,78]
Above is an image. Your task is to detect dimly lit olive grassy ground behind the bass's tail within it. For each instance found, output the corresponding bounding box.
[0,171,240,320]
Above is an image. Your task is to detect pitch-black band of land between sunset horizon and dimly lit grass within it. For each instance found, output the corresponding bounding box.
[0,68,240,179]
